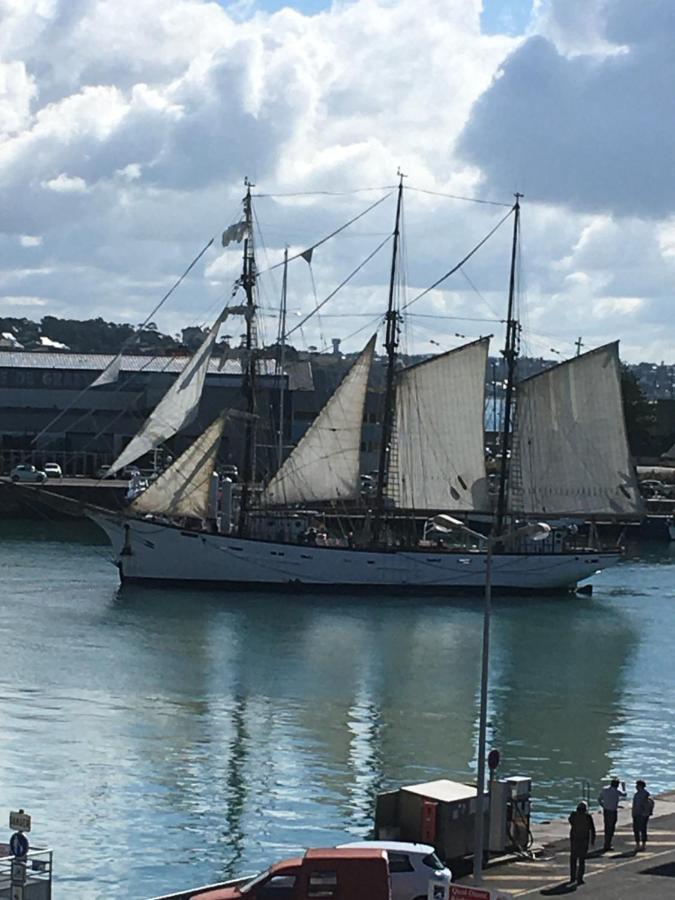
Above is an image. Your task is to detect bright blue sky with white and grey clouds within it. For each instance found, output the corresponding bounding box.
[0,0,675,364]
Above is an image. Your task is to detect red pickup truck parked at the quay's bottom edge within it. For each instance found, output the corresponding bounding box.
[191,847,391,900]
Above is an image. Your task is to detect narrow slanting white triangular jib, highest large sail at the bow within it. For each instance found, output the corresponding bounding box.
[108,313,224,475]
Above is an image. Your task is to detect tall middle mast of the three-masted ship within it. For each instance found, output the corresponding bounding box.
[373,170,405,543]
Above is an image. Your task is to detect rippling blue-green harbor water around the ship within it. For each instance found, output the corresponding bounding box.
[0,520,675,900]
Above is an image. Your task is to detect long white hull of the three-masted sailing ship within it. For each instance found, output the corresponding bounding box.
[90,511,620,593]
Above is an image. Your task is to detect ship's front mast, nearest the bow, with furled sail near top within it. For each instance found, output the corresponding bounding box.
[237,178,257,537]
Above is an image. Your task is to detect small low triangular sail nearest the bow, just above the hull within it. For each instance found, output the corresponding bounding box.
[130,413,227,519]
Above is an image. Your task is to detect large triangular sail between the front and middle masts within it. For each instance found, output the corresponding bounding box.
[263,336,375,505]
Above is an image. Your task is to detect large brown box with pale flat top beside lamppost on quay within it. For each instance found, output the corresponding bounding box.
[375,778,488,859]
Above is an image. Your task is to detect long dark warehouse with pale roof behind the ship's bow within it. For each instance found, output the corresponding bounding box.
[0,350,313,474]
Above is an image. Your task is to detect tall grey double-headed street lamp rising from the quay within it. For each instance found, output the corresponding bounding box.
[431,513,551,885]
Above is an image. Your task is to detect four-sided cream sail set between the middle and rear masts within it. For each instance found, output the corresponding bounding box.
[387,338,490,510]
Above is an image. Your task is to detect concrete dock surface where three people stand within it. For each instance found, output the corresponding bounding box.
[456,791,675,900]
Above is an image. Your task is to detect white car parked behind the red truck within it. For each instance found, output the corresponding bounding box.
[340,841,452,900]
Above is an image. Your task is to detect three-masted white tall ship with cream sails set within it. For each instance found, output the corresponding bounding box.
[87,177,642,594]
